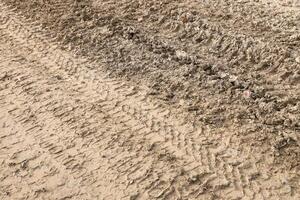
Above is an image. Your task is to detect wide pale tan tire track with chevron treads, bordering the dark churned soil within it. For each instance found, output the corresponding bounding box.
[1,1,298,199]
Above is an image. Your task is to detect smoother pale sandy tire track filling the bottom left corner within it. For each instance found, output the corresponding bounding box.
[0,111,91,199]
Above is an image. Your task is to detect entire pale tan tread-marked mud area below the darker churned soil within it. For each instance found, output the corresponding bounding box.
[0,1,297,199]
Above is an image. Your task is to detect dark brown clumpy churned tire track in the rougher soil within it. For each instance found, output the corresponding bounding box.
[2,1,299,156]
